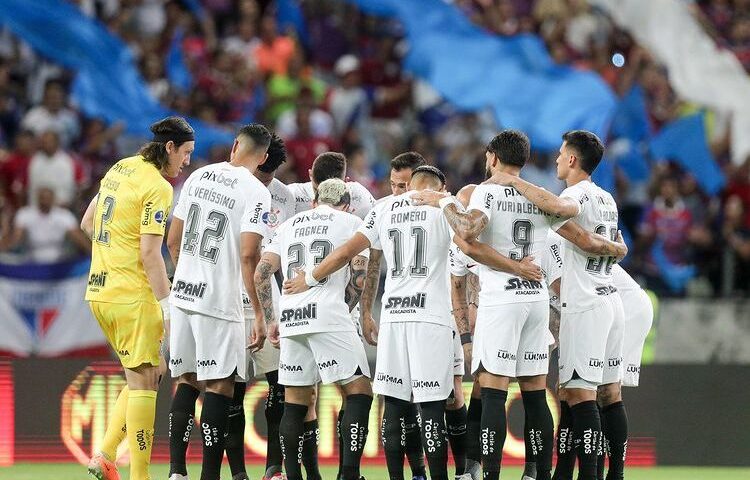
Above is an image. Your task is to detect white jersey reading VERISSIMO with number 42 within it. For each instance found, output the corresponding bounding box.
[170,162,271,322]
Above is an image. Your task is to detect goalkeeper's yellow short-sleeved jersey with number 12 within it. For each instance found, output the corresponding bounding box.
[86,155,172,303]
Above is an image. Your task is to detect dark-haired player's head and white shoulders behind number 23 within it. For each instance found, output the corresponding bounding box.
[289,152,375,218]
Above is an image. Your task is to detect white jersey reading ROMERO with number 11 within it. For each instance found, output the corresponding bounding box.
[359,192,453,326]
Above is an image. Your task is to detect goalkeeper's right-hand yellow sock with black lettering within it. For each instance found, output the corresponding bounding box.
[125,390,156,480]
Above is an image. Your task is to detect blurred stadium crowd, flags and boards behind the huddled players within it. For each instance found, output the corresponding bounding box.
[0,0,750,478]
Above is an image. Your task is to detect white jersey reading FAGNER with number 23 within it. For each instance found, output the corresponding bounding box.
[265,205,367,337]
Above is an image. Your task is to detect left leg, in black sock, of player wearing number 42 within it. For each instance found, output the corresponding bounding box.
[169,373,201,480]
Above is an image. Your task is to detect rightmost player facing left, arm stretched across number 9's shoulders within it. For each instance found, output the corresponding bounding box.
[494,130,625,480]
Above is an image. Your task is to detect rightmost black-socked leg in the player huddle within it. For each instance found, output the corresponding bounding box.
[597,382,628,480]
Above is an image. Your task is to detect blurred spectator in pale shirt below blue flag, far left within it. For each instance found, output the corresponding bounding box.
[21,81,80,147]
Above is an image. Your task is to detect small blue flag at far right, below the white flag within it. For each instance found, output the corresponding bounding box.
[651,113,726,195]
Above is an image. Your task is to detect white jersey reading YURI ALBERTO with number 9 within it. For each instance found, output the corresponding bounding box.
[468,184,557,306]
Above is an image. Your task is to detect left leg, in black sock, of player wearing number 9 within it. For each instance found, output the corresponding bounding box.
[478,374,510,480]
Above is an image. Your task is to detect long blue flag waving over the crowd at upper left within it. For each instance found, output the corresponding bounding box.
[0,0,233,155]
